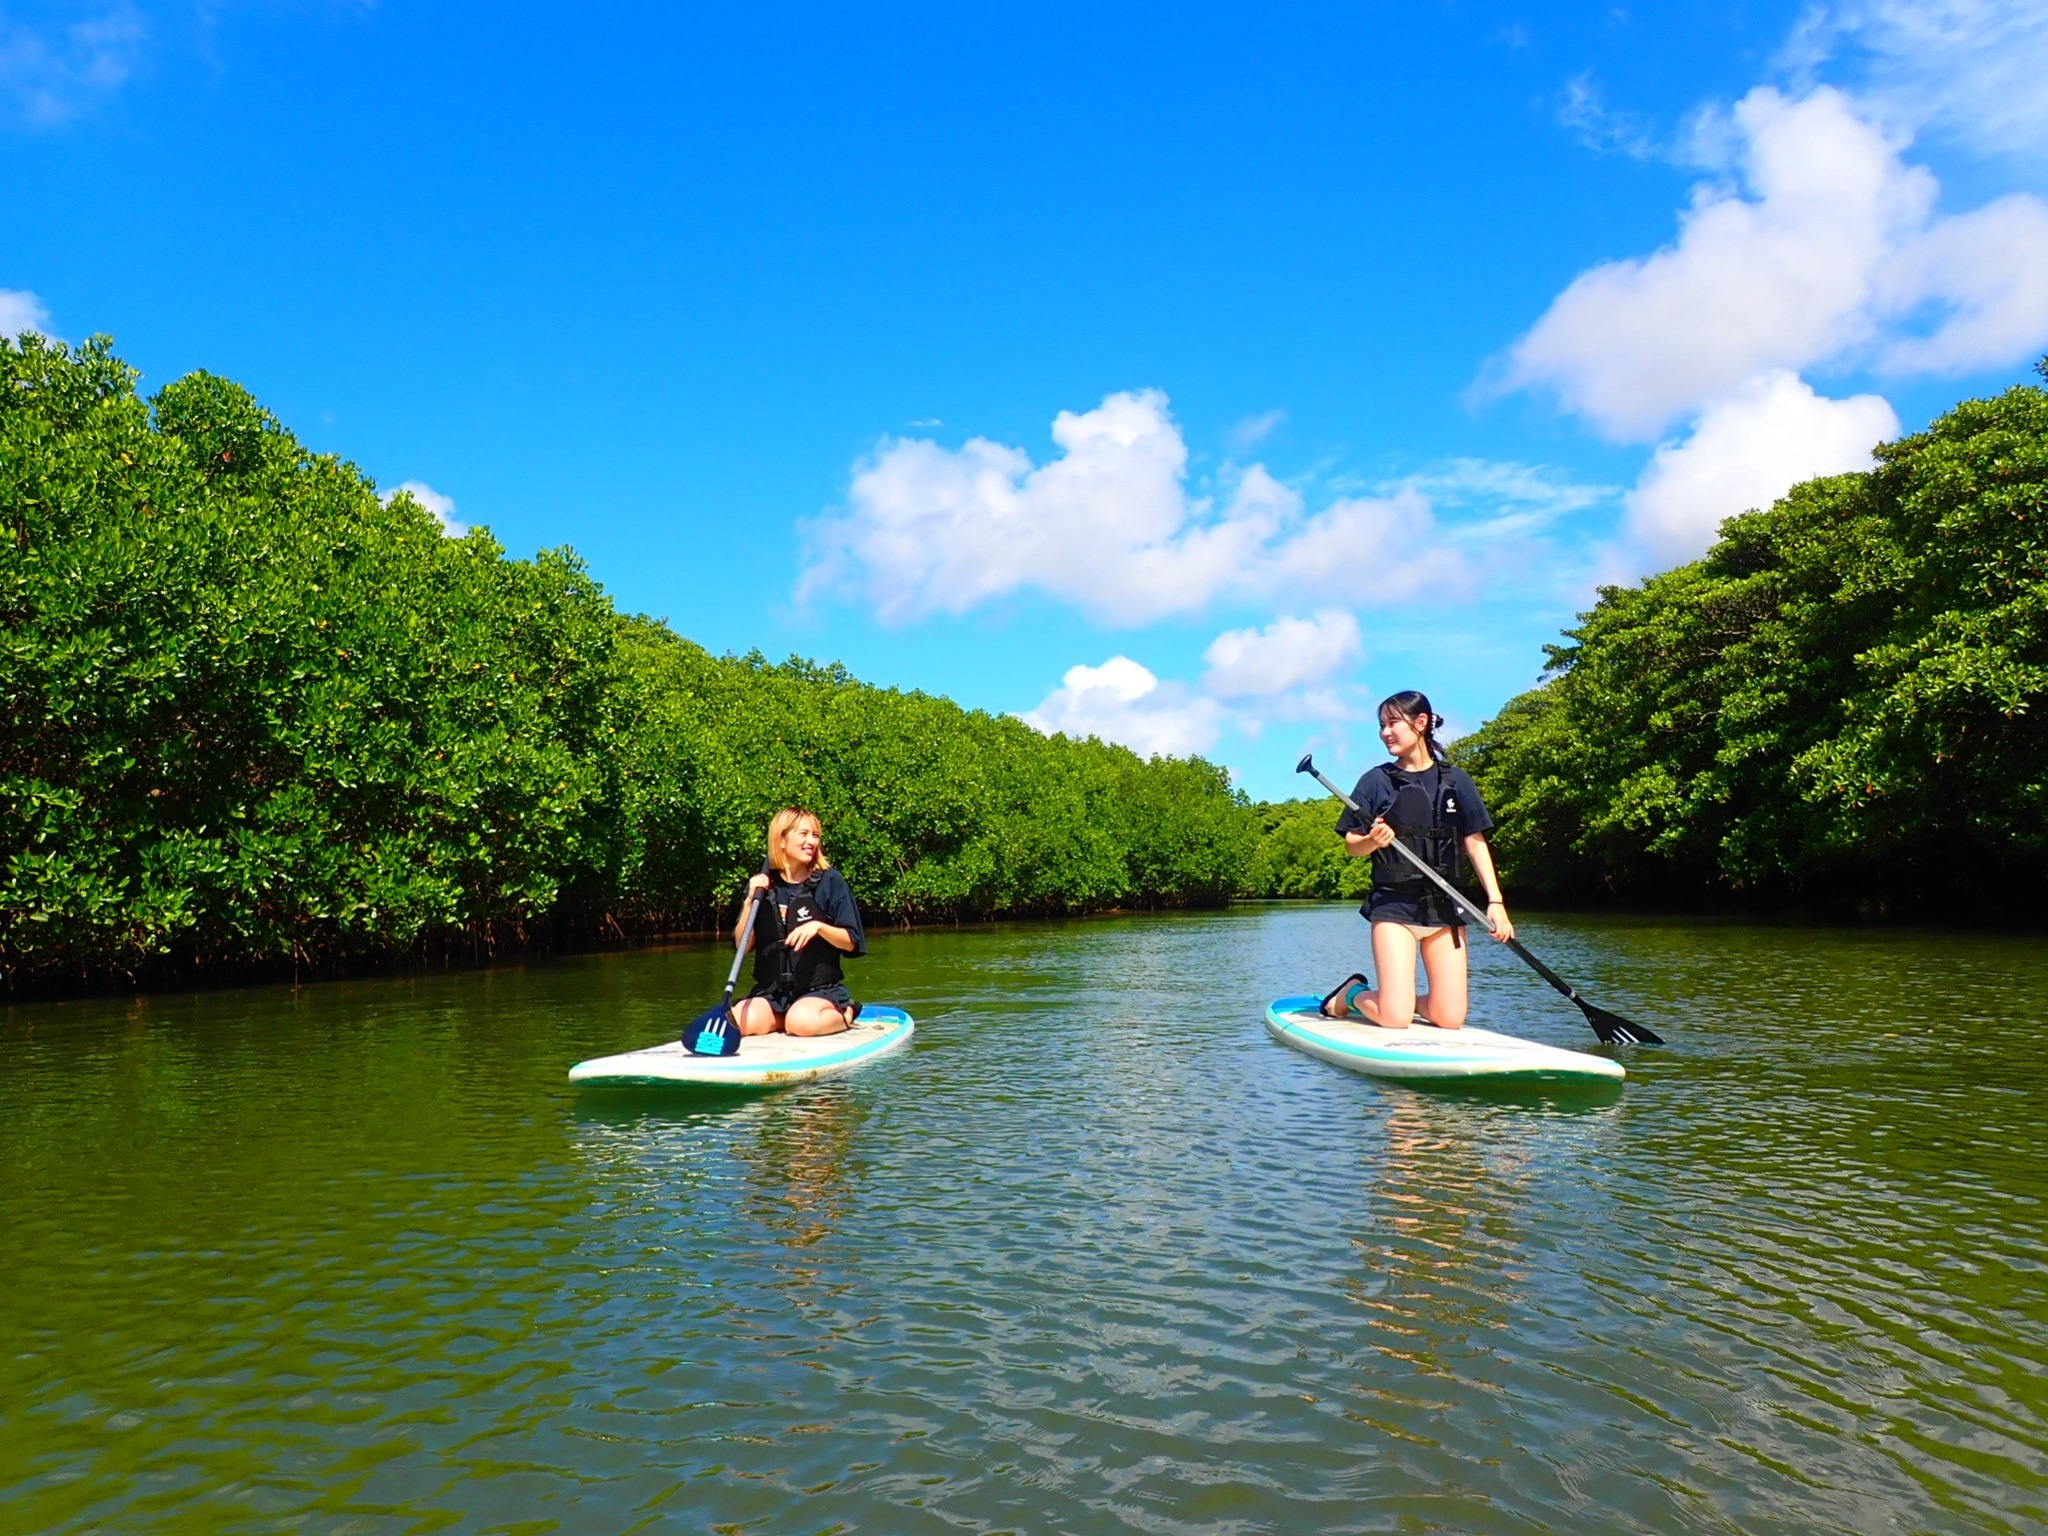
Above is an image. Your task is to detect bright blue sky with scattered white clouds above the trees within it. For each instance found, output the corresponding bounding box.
[0,0,2048,797]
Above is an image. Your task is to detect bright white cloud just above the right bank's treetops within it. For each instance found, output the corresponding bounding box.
[1626,371,1898,563]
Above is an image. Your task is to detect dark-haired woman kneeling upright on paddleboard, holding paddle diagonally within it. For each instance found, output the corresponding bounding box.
[1323,690,1516,1030]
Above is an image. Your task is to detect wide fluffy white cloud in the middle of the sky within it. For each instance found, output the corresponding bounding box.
[797,389,1470,625]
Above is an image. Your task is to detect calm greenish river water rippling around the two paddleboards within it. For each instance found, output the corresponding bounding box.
[0,905,2048,1536]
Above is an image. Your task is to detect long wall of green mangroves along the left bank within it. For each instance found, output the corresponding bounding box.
[0,336,1257,987]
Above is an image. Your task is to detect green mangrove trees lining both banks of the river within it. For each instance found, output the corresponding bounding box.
[0,334,2048,995]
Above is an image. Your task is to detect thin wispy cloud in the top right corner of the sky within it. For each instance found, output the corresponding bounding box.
[1788,0,2048,156]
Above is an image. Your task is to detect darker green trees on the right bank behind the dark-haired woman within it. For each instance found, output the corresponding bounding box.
[1460,370,2048,905]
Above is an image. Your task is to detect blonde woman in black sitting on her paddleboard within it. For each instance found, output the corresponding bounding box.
[733,809,868,1034]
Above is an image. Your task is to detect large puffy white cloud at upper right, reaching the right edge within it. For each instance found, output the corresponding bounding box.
[1501,86,2048,440]
